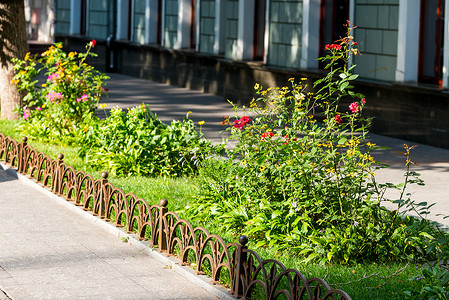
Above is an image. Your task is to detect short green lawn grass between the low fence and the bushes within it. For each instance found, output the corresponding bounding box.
[0,120,419,299]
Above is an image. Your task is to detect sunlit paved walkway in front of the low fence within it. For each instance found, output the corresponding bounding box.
[0,166,224,300]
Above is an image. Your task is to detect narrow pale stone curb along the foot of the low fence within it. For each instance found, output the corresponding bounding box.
[0,162,236,300]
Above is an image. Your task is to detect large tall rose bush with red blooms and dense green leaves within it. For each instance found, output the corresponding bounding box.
[187,22,438,263]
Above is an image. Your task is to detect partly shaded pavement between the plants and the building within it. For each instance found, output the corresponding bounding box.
[103,74,449,226]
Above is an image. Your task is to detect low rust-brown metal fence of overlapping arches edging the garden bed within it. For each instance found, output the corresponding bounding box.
[0,133,351,300]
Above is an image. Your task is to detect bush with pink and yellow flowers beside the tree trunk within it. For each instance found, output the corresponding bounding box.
[12,40,109,144]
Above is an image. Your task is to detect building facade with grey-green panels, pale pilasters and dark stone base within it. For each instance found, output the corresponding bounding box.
[55,0,449,148]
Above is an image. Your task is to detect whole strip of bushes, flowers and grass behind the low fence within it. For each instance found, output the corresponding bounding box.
[0,23,448,299]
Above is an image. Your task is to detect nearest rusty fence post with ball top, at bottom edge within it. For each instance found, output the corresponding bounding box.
[231,235,248,298]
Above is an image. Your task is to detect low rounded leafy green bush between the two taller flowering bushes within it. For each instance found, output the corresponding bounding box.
[79,104,209,176]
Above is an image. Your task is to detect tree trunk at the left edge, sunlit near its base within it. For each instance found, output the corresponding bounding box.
[0,0,28,120]
